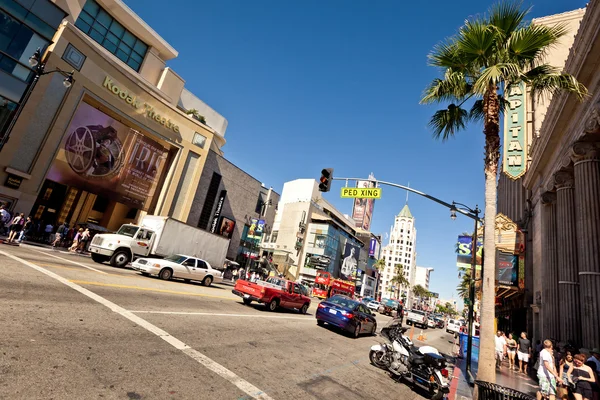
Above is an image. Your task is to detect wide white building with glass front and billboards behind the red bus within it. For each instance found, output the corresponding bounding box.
[261,179,372,286]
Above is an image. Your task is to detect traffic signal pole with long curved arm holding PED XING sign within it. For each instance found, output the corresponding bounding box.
[328,175,483,374]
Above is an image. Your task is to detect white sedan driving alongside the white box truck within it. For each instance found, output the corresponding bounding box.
[131,254,223,286]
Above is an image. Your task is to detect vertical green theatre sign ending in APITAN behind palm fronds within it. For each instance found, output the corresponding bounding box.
[502,82,527,180]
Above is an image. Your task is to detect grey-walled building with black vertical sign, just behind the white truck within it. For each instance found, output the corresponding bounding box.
[187,150,279,267]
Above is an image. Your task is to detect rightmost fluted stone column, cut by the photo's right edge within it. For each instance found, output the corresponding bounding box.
[573,142,600,348]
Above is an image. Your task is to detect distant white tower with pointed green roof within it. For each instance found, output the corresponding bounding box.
[379,204,417,304]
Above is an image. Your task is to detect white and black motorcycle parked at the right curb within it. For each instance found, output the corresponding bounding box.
[369,320,450,400]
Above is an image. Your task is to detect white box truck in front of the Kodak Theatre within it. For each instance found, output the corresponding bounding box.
[89,215,229,268]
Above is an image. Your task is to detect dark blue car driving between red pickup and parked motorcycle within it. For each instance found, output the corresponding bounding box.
[315,295,377,338]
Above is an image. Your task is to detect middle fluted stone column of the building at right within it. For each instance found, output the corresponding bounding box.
[554,171,581,342]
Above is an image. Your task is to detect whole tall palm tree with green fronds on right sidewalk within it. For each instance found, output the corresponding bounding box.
[421,3,587,382]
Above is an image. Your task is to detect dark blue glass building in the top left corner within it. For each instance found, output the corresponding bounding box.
[0,0,67,144]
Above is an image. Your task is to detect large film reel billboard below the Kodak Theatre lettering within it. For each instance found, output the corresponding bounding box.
[47,102,169,211]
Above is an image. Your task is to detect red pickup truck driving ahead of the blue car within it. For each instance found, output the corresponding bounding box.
[232,277,310,314]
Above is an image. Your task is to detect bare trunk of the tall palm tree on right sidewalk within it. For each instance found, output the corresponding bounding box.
[477,85,500,383]
